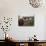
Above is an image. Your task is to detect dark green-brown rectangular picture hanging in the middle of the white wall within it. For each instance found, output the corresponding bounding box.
[18,16,34,26]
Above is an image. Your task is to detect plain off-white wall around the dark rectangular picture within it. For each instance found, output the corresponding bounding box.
[0,0,46,40]
